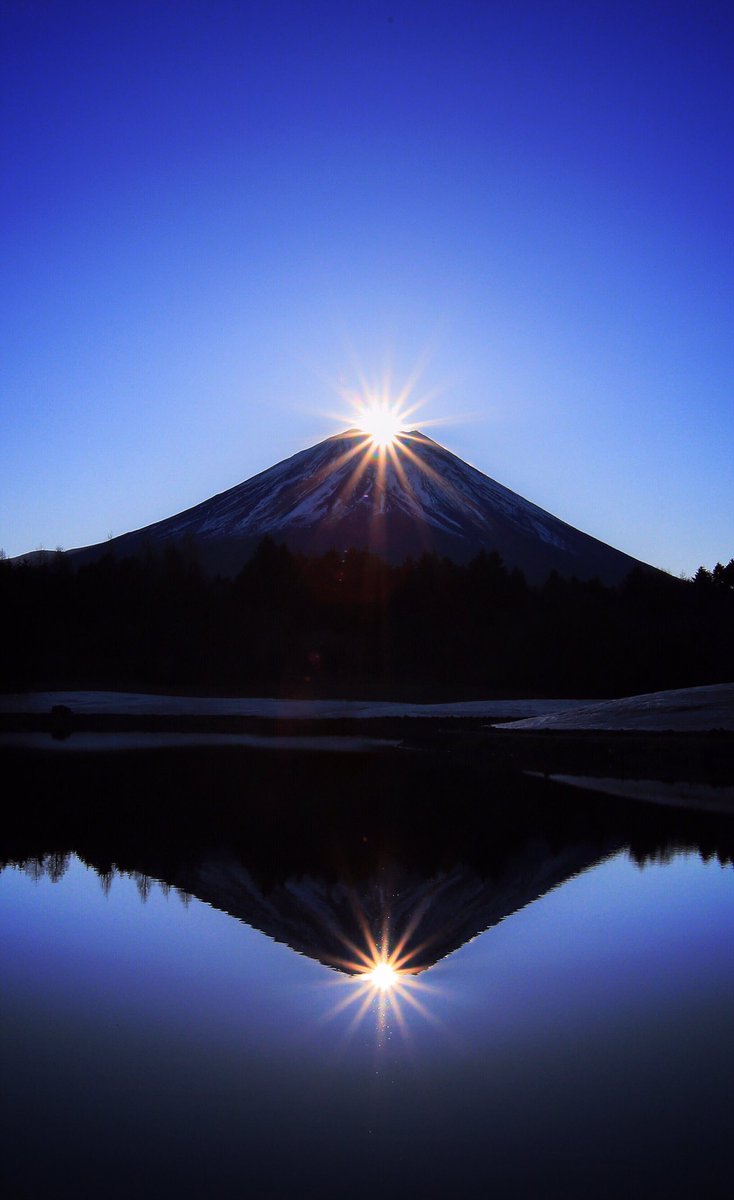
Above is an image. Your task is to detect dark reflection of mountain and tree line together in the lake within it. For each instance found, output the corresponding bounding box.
[5,748,734,974]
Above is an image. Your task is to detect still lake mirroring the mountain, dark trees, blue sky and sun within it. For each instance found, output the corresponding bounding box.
[0,746,734,1198]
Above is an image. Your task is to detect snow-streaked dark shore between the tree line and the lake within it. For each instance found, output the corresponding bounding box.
[0,684,734,812]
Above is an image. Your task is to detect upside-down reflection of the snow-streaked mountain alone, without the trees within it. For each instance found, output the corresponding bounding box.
[136,841,620,974]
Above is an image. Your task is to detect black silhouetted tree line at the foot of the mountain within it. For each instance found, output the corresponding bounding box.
[0,538,734,700]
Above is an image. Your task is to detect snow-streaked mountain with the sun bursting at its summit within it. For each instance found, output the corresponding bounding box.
[62,430,644,583]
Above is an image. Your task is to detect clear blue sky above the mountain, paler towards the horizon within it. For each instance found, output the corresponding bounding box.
[0,0,734,574]
